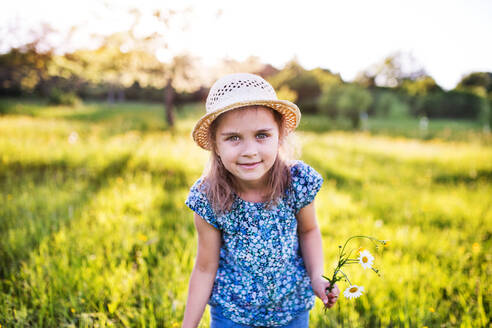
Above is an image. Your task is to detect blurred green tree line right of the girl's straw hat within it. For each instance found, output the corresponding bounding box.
[270,54,492,127]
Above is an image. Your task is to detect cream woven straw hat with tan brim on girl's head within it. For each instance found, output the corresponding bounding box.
[193,73,301,150]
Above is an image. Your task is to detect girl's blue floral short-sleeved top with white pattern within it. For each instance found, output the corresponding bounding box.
[185,161,323,326]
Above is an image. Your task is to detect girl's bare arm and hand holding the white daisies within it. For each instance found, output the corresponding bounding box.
[297,201,339,307]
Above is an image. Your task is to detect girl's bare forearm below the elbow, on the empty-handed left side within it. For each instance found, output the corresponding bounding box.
[182,265,217,328]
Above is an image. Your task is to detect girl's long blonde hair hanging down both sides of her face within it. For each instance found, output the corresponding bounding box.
[202,106,293,214]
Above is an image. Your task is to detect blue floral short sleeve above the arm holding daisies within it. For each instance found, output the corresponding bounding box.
[291,161,323,214]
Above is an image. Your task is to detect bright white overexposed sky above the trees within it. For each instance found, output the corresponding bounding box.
[0,0,492,89]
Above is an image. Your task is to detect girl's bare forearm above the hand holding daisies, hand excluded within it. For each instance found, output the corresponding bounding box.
[299,227,324,280]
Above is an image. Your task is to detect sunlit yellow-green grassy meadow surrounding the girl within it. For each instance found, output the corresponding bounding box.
[0,100,492,328]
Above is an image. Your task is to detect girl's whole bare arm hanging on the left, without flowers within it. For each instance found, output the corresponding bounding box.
[182,213,221,328]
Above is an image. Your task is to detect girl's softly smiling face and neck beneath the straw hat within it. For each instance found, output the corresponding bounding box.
[215,106,279,188]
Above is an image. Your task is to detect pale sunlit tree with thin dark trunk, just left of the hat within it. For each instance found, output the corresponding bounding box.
[59,2,200,126]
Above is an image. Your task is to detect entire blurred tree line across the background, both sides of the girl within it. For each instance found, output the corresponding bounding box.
[0,43,492,127]
